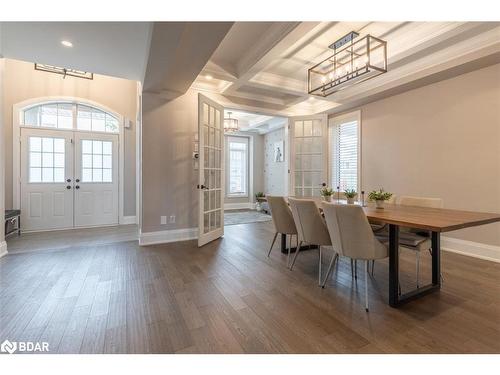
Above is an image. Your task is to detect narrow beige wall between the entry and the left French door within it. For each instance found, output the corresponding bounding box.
[141,90,198,233]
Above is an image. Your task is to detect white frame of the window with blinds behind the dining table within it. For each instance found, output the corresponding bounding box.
[328,110,363,194]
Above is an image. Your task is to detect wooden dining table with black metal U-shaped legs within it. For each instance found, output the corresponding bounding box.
[286,197,500,307]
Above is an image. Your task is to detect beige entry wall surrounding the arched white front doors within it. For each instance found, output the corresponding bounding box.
[3,59,137,216]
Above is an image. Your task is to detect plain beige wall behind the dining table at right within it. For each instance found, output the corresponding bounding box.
[361,65,500,246]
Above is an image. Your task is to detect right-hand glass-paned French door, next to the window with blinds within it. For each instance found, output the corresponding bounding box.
[289,115,328,197]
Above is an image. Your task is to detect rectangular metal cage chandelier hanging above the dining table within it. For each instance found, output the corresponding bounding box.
[307,31,387,97]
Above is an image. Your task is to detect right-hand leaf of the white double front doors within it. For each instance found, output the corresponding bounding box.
[74,132,118,227]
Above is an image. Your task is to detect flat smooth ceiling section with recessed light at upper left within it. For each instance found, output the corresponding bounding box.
[0,22,152,81]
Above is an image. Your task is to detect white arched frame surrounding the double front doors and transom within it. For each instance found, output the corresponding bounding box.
[12,96,129,228]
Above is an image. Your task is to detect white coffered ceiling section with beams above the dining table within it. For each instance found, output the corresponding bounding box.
[192,22,500,116]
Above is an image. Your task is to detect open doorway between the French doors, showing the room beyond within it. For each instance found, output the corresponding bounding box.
[224,109,288,226]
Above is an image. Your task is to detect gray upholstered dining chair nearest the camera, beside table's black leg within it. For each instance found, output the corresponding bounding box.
[322,203,389,311]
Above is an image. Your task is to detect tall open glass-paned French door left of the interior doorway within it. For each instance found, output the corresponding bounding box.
[198,94,225,246]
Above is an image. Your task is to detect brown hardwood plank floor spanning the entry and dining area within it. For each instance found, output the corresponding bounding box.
[0,223,500,353]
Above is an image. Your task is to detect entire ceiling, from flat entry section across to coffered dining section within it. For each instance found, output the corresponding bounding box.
[0,22,500,117]
